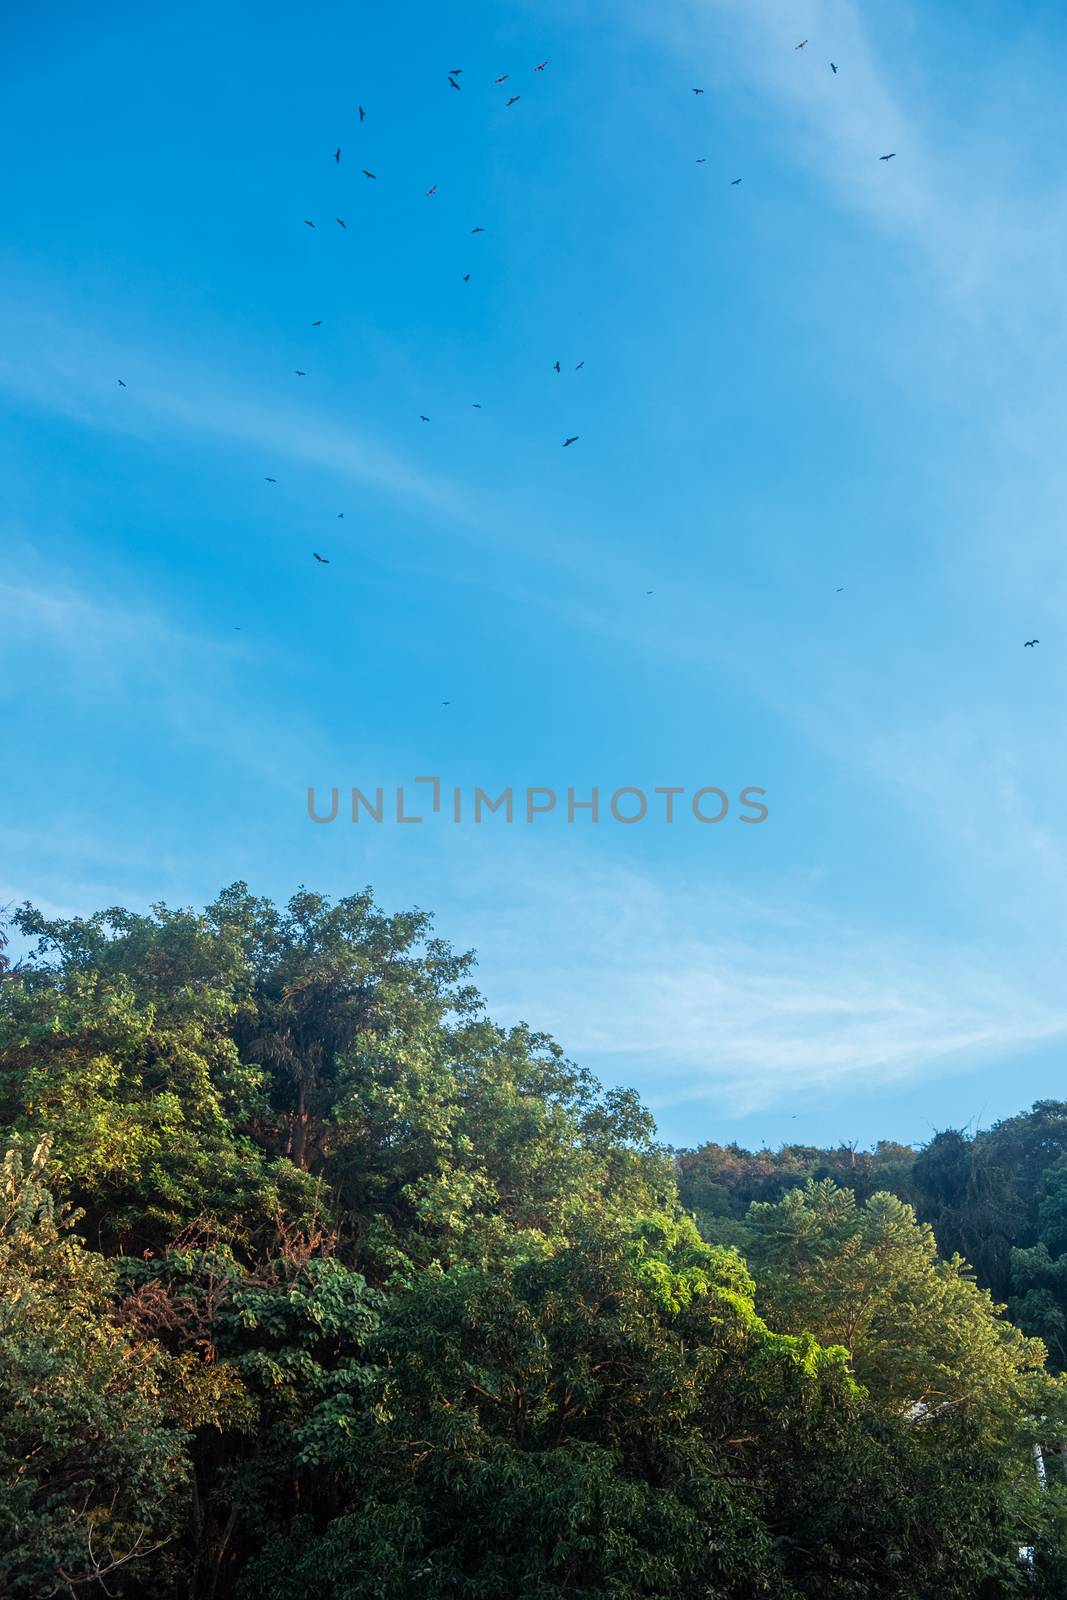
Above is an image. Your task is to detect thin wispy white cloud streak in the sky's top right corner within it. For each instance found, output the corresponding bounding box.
[652,0,1067,318]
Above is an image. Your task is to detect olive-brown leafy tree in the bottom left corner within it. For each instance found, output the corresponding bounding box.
[0,1144,227,1597]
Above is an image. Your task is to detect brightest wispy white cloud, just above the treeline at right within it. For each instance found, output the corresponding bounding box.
[435,859,1067,1115]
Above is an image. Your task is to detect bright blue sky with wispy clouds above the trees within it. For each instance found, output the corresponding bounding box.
[0,0,1067,1144]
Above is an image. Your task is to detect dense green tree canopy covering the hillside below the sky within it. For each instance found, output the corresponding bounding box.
[0,883,1067,1600]
